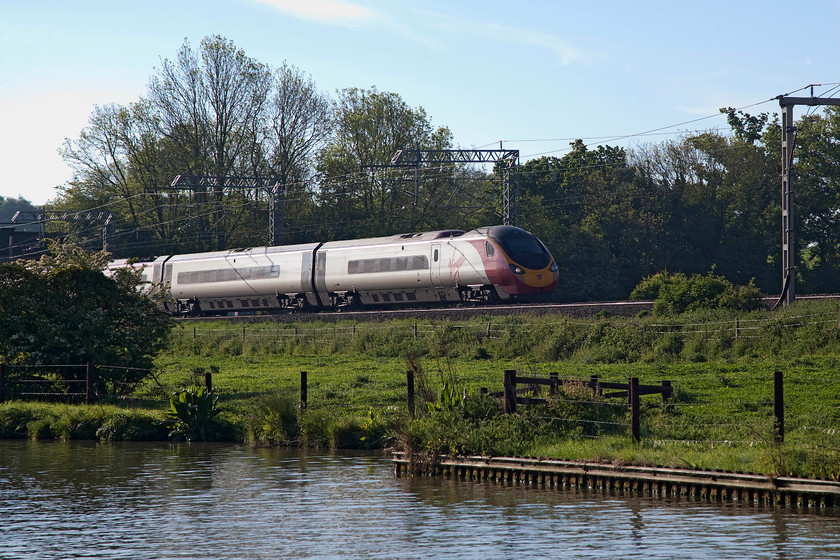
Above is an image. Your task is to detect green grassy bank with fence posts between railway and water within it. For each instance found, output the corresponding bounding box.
[0,302,840,478]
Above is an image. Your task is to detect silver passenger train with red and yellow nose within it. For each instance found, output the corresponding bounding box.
[109,226,560,316]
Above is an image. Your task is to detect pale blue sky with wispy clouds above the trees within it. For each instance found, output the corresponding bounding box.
[0,0,840,204]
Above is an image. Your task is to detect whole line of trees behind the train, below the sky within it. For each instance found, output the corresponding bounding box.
[53,36,840,301]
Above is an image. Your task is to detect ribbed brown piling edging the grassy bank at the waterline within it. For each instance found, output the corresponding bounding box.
[393,453,840,509]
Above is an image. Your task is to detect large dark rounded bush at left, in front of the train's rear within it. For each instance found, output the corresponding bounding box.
[0,244,173,390]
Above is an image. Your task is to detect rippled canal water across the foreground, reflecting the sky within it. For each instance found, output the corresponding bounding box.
[0,441,840,560]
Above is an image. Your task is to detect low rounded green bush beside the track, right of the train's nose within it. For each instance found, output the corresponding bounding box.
[630,272,762,315]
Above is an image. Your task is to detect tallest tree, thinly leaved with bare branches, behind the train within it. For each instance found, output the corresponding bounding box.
[149,36,271,249]
